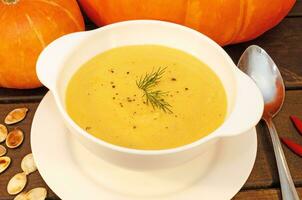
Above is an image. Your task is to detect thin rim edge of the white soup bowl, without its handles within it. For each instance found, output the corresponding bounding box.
[52,20,244,156]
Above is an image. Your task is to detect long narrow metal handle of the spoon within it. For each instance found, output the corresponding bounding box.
[265,118,299,200]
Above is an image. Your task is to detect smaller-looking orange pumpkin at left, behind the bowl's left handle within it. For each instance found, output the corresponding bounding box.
[0,0,84,89]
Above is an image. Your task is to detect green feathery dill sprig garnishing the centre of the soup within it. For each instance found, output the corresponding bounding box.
[136,67,173,113]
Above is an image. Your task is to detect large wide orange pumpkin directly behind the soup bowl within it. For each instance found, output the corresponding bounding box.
[79,0,295,45]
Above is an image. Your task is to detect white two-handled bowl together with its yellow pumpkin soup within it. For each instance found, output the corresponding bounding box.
[37,20,263,169]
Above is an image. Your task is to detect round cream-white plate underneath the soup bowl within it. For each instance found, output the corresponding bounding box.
[31,93,257,200]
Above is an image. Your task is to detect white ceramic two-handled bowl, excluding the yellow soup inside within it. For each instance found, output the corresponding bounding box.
[37,20,263,169]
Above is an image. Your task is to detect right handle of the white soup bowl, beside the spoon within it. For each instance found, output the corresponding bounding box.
[219,69,264,137]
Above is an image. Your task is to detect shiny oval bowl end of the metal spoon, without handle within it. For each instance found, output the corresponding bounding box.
[238,45,285,120]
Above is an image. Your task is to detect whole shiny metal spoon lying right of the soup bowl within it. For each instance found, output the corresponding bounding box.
[237,45,299,200]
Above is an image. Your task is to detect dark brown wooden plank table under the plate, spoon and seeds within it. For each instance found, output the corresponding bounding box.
[0,0,302,200]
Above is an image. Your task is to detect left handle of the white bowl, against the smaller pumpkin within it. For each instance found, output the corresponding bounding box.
[36,32,87,90]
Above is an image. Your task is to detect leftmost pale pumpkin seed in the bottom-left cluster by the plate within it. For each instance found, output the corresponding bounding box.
[7,172,27,195]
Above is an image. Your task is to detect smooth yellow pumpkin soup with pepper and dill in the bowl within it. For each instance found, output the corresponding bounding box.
[66,45,227,150]
